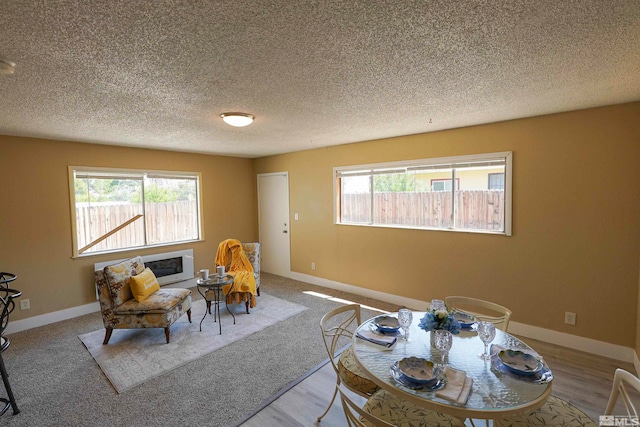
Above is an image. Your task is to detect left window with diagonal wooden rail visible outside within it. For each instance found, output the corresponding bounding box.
[69,166,201,256]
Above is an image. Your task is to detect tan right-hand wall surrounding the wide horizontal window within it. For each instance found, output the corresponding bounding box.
[255,103,640,348]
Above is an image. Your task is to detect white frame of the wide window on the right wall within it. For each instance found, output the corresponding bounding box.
[333,151,513,236]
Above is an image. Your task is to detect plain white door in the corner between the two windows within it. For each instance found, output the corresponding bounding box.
[258,172,291,277]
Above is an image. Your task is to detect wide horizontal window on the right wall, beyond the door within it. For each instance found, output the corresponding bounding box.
[334,152,512,235]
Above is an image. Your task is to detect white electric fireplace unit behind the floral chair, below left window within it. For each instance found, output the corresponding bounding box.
[94,249,195,286]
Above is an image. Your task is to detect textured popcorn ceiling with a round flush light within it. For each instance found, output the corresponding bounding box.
[0,0,640,158]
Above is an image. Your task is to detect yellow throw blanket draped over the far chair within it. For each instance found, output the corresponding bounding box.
[216,239,257,308]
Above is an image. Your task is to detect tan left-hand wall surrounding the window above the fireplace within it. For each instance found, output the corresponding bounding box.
[0,136,258,320]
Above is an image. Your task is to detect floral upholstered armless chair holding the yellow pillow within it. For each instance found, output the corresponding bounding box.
[95,256,191,344]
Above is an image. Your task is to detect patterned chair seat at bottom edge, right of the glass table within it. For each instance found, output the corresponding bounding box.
[496,395,597,427]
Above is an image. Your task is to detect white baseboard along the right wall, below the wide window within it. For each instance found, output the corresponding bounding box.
[289,271,640,366]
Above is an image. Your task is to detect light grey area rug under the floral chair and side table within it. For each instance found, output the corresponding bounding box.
[78,293,307,393]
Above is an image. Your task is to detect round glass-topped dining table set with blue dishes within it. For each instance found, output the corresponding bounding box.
[353,312,553,420]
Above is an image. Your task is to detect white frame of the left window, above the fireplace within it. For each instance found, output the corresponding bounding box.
[68,166,204,259]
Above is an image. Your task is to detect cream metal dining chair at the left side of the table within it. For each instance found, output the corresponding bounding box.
[318,304,379,421]
